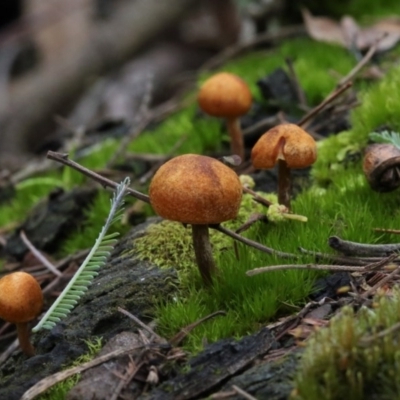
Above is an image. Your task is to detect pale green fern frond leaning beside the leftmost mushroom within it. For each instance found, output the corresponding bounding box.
[32,178,130,332]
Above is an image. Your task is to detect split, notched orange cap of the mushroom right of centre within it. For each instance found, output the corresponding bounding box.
[251,124,317,169]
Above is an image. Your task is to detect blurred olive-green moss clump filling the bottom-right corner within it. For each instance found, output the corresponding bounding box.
[292,287,400,400]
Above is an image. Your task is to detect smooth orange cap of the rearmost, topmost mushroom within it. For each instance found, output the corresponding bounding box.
[197,72,252,118]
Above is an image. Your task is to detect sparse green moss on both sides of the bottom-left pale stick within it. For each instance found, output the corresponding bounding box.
[38,338,103,400]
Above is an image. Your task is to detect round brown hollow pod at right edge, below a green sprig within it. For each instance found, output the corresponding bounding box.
[363,143,400,192]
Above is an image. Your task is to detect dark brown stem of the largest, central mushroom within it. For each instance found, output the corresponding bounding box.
[192,224,217,286]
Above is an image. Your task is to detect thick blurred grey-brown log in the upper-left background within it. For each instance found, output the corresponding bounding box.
[0,0,195,162]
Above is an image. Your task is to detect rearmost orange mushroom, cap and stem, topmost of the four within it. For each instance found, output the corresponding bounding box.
[197,72,252,161]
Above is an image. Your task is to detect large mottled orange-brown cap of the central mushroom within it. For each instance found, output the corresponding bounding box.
[149,154,242,225]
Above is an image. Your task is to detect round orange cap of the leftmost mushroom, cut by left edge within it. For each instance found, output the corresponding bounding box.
[0,272,43,323]
